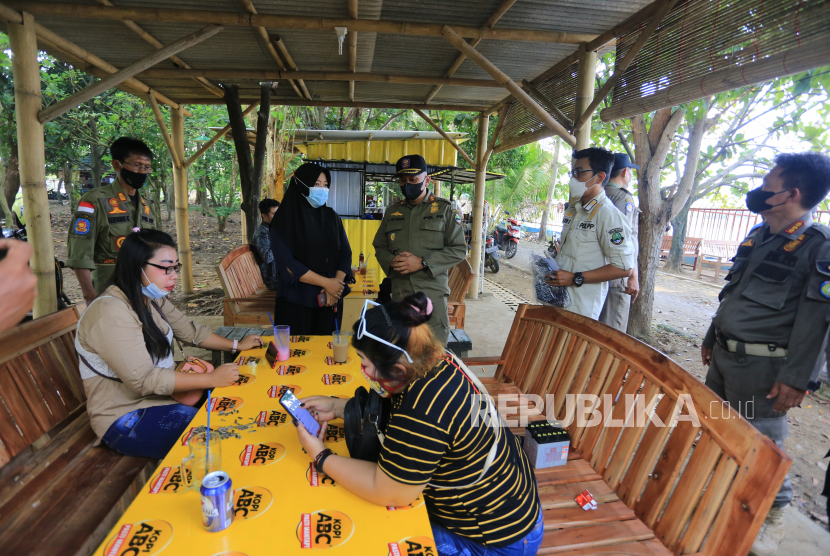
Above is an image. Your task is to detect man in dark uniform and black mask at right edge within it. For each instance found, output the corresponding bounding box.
[701,153,830,556]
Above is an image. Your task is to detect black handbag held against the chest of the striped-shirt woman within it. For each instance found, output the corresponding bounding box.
[343,386,391,462]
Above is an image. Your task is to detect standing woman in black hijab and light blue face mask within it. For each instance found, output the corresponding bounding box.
[270,163,352,335]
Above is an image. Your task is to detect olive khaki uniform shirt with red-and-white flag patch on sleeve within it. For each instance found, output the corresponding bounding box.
[66,179,160,294]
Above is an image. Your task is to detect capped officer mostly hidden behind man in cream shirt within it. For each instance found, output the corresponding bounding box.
[599,153,640,332]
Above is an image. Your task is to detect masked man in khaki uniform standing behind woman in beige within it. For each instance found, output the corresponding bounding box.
[66,137,160,303]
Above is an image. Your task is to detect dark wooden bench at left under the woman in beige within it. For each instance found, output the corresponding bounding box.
[0,306,157,556]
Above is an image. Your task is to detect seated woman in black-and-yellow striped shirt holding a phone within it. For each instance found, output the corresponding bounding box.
[295,292,544,556]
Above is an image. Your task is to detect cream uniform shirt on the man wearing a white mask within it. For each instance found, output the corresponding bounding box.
[556,191,635,320]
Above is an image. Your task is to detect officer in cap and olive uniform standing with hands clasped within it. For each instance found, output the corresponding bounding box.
[372,155,467,345]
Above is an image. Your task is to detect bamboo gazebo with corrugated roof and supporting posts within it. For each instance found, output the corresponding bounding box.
[0,0,830,317]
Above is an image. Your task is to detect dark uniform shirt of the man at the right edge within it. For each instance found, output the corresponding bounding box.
[703,212,830,390]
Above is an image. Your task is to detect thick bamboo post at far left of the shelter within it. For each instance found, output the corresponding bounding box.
[8,12,58,318]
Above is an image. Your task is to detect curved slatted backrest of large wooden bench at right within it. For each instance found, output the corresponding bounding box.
[496,305,791,556]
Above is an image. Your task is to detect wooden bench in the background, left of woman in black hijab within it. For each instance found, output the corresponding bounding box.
[216,245,276,326]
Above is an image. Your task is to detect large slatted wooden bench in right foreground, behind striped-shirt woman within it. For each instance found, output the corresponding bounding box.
[465,305,791,556]
